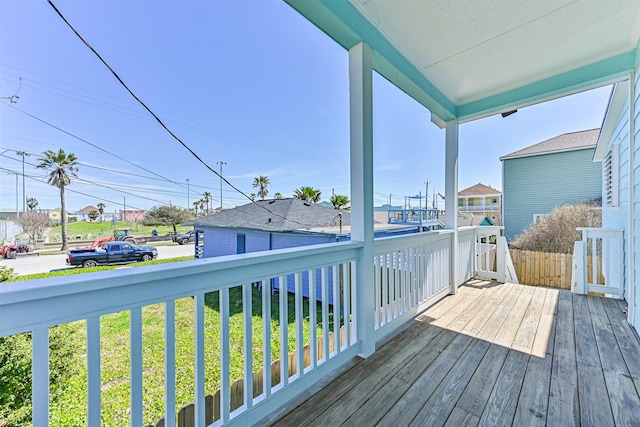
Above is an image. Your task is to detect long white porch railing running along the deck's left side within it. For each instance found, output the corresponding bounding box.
[0,227,508,426]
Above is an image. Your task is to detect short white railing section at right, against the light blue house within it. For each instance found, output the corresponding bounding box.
[571,228,624,299]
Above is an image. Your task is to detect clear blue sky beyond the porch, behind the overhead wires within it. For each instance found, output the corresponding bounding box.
[0,0,610,212]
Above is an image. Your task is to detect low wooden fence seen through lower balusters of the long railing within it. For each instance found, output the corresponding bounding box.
[146,325,345,427]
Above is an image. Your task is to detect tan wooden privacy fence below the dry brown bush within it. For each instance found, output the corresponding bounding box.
[509,249,605,289]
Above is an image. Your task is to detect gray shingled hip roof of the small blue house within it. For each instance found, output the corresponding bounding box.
[186,199,351,231]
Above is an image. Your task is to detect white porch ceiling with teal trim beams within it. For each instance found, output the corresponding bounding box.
[286,0,640,121]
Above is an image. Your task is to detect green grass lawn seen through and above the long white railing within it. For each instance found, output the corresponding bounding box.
[0,257,333,426]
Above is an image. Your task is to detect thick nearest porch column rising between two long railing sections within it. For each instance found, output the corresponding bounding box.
[349,43,375,357]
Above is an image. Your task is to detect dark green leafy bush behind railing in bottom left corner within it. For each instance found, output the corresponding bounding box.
[0,324,82,426]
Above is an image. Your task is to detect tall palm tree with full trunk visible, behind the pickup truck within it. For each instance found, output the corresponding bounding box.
[36,148,78,250]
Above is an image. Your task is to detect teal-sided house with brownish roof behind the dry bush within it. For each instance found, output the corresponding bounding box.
[500,129,602,240]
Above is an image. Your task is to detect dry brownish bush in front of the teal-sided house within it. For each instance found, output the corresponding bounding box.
[510,203,602,253]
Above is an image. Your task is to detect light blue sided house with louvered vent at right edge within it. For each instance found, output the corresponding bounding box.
[593,79,640,331]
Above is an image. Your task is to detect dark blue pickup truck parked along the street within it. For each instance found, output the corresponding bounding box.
[67,242,158,268]
